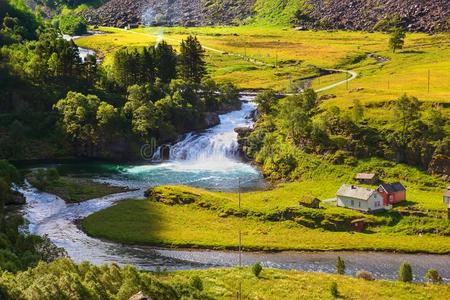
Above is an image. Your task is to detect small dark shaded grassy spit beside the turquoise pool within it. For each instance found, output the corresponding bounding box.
[28,176,129,203]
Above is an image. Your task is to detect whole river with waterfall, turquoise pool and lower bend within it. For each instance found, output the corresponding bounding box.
[21,96,450,281]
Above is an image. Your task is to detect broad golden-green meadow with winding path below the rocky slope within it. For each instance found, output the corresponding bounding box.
[77,25,450,107]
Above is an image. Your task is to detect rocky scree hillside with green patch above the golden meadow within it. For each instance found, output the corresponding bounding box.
[84,0,450,32]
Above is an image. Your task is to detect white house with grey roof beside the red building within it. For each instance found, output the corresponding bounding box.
[336,184,392,212]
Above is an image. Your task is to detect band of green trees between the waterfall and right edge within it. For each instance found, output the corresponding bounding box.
[245,90,450,177]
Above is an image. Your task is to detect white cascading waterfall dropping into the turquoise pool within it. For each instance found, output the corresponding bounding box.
[153,96,255,163]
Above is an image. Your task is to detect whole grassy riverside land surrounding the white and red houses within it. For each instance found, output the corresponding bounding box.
[83,155,450,253]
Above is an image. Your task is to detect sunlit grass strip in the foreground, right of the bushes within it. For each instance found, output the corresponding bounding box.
[162,268,450,300]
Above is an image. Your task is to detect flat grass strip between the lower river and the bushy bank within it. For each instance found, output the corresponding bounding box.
[82,199,450,253]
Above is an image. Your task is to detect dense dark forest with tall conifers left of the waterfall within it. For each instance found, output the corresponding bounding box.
[0,2,240,160]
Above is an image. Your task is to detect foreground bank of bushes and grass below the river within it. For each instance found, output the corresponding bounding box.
[0,259,450,300]
